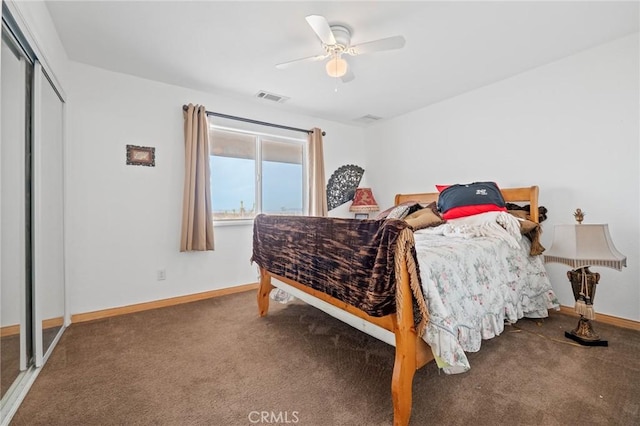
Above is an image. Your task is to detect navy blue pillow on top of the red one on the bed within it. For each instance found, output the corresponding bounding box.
[438,182,505,213]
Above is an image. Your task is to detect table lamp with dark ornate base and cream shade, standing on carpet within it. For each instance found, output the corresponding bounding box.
[544,209,627,346]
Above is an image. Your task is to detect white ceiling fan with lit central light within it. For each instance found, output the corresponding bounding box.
[276,15,405,83]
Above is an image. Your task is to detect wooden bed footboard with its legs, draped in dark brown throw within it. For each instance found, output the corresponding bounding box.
[252,215,433,426]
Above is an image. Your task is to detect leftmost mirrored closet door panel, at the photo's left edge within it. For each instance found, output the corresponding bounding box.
[0,21,33,408]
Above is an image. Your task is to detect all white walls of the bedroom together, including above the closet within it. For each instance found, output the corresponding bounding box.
[16,2,640,320]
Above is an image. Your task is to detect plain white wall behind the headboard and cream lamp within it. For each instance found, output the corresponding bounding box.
[365,34,640,320]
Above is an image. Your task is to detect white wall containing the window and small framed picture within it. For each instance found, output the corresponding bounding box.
[67,62,366,314]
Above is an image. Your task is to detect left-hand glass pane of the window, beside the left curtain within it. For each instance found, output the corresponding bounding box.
[209,130,256,220]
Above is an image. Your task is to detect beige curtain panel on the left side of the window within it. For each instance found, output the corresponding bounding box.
[180,104,213,251]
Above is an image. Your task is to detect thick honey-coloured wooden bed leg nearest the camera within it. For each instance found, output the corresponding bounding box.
[391,265,418,426]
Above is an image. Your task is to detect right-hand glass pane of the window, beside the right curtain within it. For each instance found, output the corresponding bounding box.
[262,140,303,215]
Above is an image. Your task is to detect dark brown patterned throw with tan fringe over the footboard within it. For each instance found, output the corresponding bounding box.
[251,214,428,333]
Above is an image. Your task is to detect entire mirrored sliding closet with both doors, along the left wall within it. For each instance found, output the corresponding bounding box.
[0,3,68,426]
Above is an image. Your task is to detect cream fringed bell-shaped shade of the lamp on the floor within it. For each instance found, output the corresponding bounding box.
[544,224,627,271]
